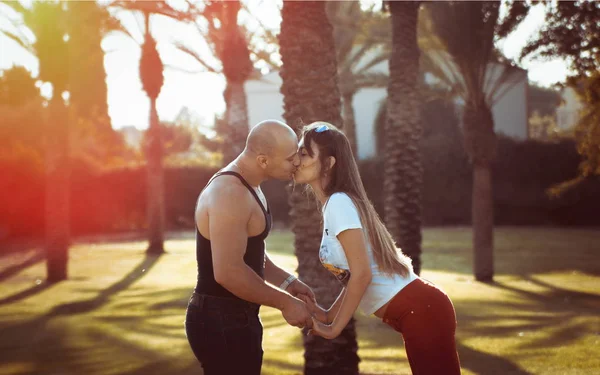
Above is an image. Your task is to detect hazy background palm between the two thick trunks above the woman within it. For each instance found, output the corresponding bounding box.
[326,1,391,155]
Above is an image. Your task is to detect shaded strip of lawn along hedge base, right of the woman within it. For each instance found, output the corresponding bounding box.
[423,227,600,276]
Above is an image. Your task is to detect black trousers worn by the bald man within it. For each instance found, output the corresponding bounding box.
[185,293,263,375]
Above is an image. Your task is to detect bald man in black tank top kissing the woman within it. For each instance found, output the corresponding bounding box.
[185,120,314,375]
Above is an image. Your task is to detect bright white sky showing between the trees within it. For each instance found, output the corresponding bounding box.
[0,0,568,129]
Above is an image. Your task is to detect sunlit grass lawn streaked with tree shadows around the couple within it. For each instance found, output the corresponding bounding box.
[0,228,600,375]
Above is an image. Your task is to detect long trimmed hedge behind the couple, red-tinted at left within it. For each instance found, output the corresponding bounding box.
[0,97,600,241]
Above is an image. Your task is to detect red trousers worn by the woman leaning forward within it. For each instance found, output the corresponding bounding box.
[383,279,460,375]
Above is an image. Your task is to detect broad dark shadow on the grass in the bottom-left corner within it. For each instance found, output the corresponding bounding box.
[0,317,202,375]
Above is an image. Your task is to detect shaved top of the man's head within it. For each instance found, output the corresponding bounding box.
[246,120,298,156]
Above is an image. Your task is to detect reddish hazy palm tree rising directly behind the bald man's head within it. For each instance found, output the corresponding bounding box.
[176,0,253,164]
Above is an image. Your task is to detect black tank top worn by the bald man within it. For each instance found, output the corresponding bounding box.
[194,171,271,299]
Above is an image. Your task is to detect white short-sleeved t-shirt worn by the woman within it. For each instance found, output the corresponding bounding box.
[319,193,417,315]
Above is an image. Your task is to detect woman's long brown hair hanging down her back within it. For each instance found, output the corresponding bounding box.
[302,121,412,276]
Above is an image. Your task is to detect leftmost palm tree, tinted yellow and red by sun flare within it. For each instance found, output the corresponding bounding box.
[3,2,70,282]
